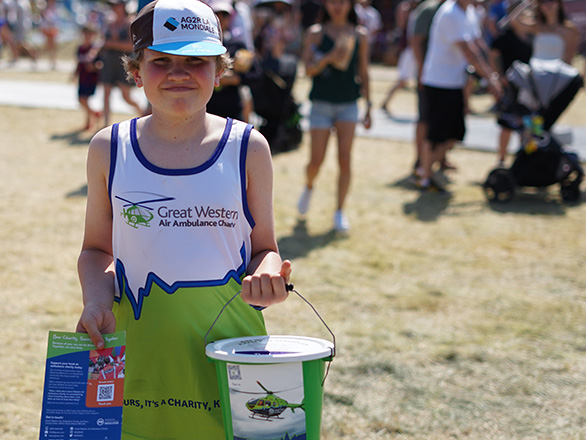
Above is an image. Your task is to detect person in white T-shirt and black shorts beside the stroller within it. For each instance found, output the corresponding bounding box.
[418,0,502,196]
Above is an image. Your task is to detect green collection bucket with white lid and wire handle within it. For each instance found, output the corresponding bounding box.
[206,287,335,440]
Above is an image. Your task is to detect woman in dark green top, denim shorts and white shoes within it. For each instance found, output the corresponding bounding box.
[297,0,371,232]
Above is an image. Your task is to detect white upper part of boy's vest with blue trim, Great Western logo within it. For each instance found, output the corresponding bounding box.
[109,115,254,319]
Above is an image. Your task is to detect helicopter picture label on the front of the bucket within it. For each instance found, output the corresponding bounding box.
[226,362,306,440]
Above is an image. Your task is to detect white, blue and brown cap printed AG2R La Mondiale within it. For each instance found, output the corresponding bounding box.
[130,0,226,56]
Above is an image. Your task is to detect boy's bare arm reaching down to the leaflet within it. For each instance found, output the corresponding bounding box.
[76,128,116,348]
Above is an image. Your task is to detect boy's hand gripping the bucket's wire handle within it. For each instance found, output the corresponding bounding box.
[241,260,291,307]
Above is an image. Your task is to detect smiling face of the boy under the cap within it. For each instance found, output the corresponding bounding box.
[134,49,220,116]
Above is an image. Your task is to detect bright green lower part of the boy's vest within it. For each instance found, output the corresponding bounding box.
[114,280,266,440]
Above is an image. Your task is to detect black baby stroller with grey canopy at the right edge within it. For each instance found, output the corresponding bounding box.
[483,60,584,202]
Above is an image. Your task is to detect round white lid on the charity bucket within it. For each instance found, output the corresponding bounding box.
[206,335,334,364]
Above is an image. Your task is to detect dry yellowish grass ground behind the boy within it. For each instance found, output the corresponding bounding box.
[0,52,586,440]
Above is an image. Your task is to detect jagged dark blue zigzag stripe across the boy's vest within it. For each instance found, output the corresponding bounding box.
[115,244,246,320]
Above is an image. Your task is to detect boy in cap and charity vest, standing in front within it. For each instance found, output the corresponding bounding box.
[77,0,291,440]
